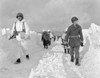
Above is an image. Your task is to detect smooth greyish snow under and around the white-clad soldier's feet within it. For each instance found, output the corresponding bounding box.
[0,31,45,78]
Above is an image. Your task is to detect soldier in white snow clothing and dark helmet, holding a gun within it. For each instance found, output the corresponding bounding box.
[9,13,29,64]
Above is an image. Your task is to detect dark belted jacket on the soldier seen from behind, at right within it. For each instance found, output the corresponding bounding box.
[65,24,83,47]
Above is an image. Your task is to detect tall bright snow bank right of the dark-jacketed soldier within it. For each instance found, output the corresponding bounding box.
[78,23,100,78]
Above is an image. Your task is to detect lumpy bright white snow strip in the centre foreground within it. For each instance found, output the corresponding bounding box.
[29,53,66,78]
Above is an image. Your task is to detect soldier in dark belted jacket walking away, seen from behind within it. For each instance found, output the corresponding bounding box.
[65,17,83,65]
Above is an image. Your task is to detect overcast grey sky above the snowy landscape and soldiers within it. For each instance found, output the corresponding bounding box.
[0,0,100,31]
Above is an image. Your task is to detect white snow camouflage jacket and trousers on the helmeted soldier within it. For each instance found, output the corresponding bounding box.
[11,20,29,58]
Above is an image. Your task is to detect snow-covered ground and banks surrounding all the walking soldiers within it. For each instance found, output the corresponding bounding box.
[0,24,100,78]
